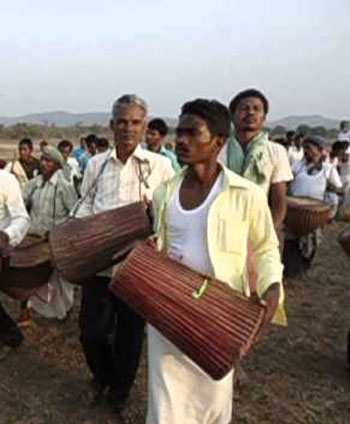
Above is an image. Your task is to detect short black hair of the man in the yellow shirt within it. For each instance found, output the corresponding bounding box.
[180,99,231,138]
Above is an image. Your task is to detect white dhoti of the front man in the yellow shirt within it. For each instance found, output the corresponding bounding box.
[146,325,233,424]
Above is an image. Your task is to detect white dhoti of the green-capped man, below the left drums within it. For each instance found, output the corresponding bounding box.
[28,270,74,319]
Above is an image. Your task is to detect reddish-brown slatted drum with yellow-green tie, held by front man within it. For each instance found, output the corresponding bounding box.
[110,243,265,380]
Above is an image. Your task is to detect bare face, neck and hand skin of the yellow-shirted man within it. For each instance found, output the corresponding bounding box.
[176,115,280,341]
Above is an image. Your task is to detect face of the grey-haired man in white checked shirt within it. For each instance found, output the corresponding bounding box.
[110,104,147,163]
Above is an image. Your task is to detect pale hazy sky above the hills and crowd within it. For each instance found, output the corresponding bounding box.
[0,0,350,119]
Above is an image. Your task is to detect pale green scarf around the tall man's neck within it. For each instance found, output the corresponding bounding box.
[227,131,268,185]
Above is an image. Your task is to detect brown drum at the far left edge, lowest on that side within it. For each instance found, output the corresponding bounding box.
[0,234,53,299]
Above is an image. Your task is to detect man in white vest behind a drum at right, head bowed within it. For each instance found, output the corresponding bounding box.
[283,136,343,278]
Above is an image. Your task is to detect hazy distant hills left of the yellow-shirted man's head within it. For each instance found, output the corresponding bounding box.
[0,111,176,127]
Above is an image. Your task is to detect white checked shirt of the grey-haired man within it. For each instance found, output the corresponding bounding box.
[76,146,174,218]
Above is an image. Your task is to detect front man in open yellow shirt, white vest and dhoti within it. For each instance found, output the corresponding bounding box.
[147,99,285,424]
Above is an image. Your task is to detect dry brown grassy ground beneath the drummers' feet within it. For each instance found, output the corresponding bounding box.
[0,223,350,424]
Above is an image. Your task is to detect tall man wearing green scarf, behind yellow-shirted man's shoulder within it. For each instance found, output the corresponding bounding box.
[221,89,293,229]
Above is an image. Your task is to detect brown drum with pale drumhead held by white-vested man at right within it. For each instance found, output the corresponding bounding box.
[285,196,331,237]
